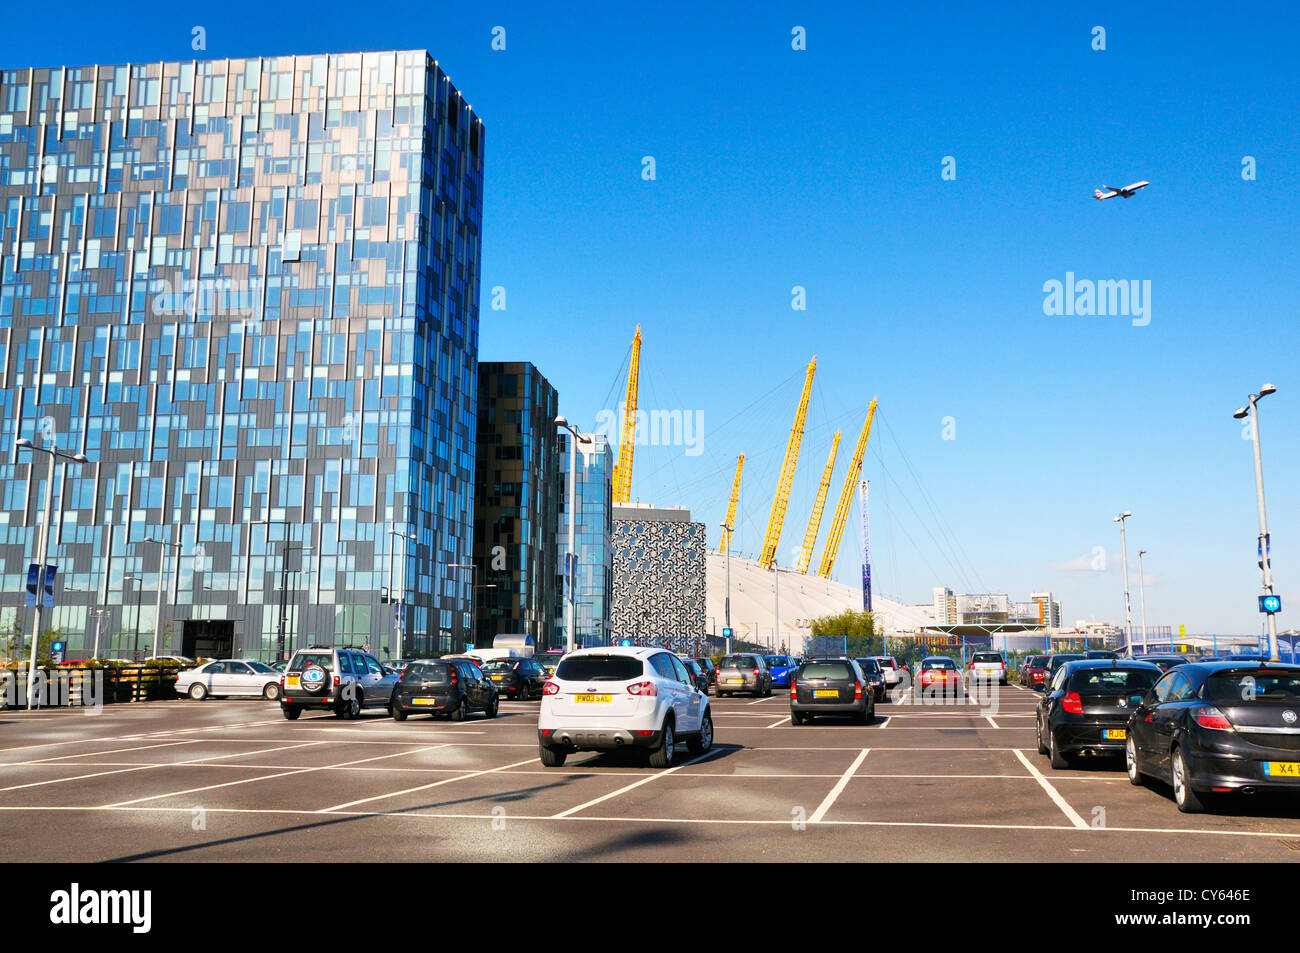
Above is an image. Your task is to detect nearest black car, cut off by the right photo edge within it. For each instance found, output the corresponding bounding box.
[1125,660,1300,814]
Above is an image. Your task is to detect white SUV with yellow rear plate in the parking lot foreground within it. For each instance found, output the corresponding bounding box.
[537,647,714,767]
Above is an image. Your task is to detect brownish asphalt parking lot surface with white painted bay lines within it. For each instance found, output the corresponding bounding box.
[0,685,1300,862]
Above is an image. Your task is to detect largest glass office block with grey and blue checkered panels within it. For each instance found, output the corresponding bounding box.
[0,51,484,658]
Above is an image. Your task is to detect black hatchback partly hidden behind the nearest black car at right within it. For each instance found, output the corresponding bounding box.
[1035,659,1161,768]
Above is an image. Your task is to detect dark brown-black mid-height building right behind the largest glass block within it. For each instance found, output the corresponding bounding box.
[465,361,560,649]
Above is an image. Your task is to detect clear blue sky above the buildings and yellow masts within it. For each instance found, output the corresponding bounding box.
[0,0,1300,632]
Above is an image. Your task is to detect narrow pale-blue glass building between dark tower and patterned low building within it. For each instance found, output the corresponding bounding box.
[551,430,614,647]
